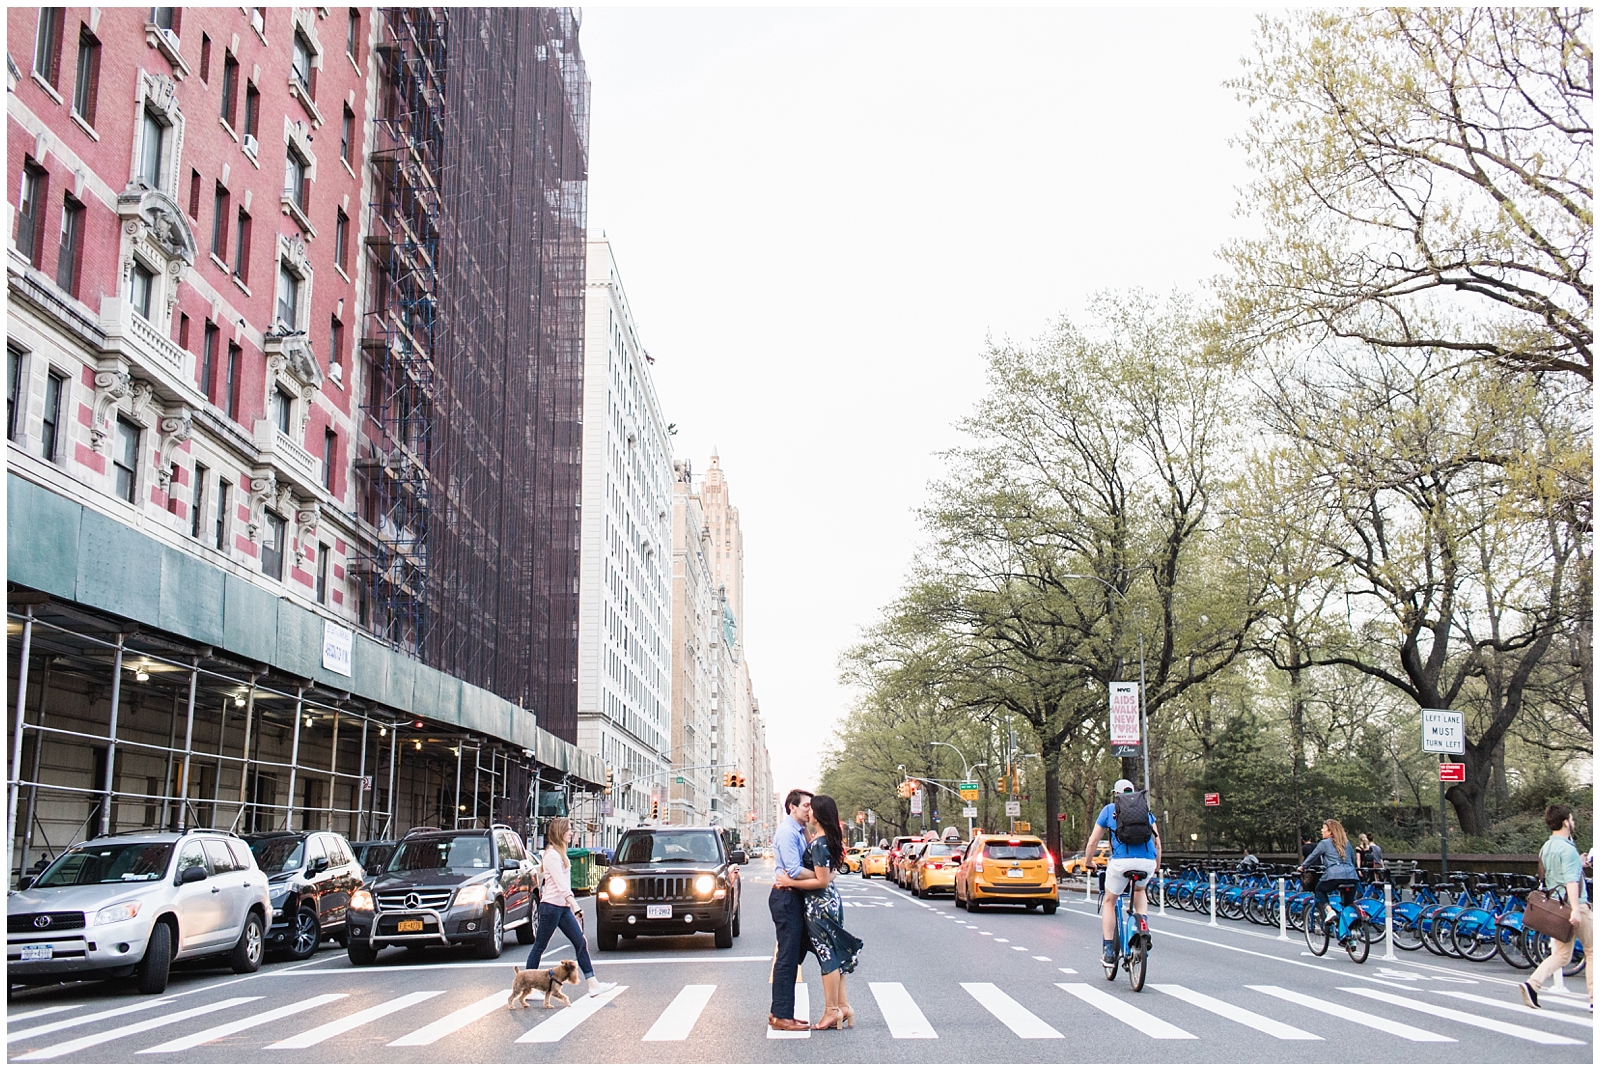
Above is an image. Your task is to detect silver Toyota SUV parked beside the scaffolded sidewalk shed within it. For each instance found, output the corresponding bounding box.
[6,829,272,993]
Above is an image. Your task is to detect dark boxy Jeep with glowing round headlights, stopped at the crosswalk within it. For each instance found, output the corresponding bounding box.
[595,826,744,953]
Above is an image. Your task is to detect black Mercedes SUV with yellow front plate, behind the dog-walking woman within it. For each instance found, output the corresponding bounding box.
[340,826,539,965]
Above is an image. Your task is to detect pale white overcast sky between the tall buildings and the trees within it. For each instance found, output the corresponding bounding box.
[579,6,1254,810]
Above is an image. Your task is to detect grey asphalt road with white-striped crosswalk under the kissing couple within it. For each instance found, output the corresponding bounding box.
[6,866,1594,1065]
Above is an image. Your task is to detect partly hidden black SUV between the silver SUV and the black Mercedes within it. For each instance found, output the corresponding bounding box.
[246,831,366,959]
